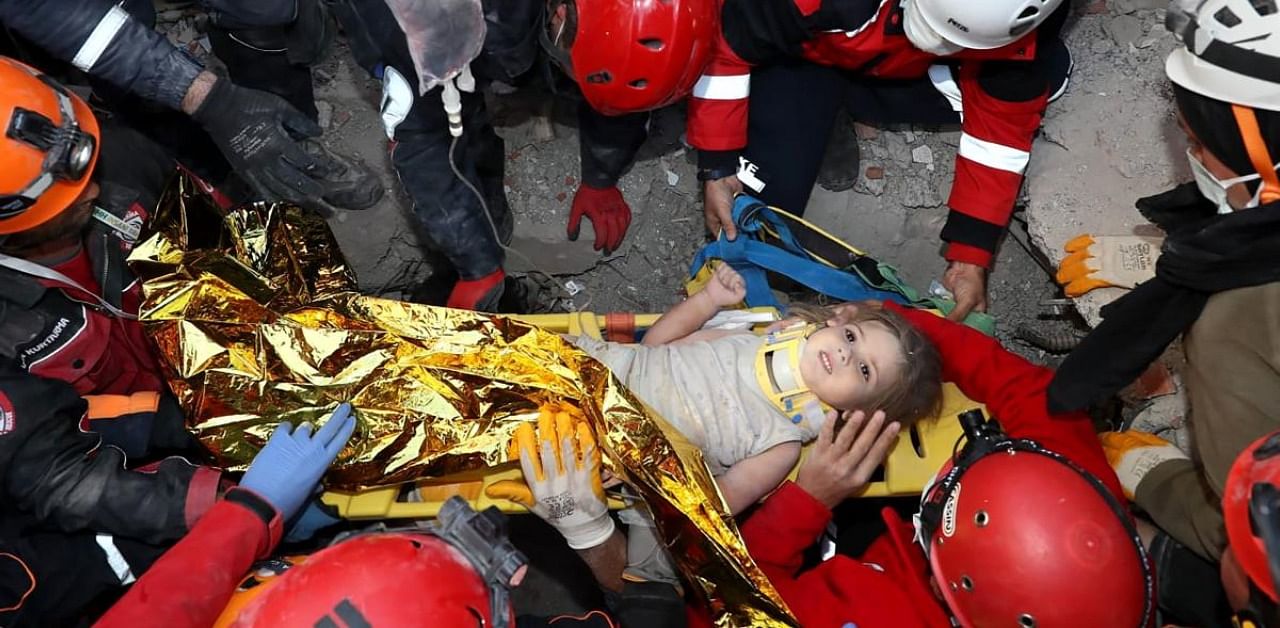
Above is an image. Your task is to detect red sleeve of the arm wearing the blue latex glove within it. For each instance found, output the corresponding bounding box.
[95,489,282,628]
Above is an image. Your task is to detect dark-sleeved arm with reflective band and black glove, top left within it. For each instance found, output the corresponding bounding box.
[0,0,381,210]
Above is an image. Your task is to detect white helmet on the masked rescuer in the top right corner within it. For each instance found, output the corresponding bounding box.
[1165,0,1280,111]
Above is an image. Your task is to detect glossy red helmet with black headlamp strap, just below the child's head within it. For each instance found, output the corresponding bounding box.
[920,412,1155,628]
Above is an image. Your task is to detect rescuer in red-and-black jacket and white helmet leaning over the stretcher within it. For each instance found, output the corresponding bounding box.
[687,0,1070,320]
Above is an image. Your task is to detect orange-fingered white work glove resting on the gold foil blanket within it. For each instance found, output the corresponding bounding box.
[485,408,614,550]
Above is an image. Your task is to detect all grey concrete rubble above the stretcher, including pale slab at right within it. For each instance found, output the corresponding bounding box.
[160,7,1185,376]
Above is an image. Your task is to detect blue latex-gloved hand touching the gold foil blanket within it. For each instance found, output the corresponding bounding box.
[241,403,356,521]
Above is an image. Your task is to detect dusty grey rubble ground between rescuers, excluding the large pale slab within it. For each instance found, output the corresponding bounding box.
[135,23,1080,359]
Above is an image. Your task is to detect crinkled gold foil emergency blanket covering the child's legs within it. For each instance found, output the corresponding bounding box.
[129,177,794,627]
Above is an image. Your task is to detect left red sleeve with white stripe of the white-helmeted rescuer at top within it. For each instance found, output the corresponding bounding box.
[686,21,751,151]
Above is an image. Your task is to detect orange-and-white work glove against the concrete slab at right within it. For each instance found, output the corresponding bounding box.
[1057,234,1165,297]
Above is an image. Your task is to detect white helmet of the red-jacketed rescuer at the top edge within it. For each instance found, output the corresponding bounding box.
[915,0,1062,50]
